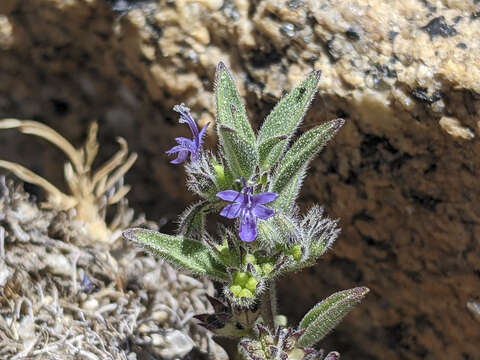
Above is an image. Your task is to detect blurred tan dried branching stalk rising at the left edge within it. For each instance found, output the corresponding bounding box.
[0,119,137,242]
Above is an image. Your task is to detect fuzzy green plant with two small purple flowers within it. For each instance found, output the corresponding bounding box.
[124,63,368,360]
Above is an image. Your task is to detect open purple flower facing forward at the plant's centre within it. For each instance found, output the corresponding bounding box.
[217,186,278,242]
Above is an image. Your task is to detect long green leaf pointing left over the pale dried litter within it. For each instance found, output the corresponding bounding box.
[123,228,229,281]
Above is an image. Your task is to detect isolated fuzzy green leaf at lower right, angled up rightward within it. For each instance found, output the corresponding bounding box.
[297,287,370,346]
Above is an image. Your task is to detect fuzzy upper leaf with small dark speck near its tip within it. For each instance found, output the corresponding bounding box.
[258,71,321,170]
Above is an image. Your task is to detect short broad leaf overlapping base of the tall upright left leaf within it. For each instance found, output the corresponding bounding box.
[218,125,258,180]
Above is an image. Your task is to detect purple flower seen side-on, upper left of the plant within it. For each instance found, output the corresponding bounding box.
[167,104,210,164]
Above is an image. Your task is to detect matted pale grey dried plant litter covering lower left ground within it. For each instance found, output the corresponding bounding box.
[0,177,218,360]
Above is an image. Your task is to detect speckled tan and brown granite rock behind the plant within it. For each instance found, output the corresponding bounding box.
[0,0,480,360]
